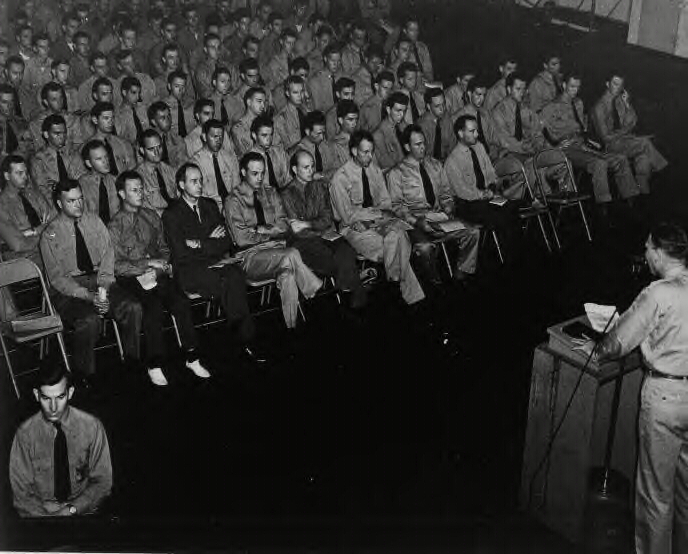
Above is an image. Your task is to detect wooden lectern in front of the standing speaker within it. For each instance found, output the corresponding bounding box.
[521,316,643,543]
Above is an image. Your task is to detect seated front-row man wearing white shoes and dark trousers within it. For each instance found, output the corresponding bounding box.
[108,170,210,386]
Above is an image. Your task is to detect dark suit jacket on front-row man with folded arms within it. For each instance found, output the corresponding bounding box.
[162,198,236,283]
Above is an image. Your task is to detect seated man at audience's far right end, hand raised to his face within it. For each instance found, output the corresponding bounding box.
[592,74,668,194]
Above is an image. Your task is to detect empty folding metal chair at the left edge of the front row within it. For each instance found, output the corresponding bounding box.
[0,258,71,398]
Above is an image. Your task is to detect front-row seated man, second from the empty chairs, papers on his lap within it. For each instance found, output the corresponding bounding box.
[387,125,480,284]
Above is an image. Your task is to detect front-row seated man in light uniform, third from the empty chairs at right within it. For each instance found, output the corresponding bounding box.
[330,131,425,304]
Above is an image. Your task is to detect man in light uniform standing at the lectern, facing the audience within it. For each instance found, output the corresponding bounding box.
[597,223,688,554]
